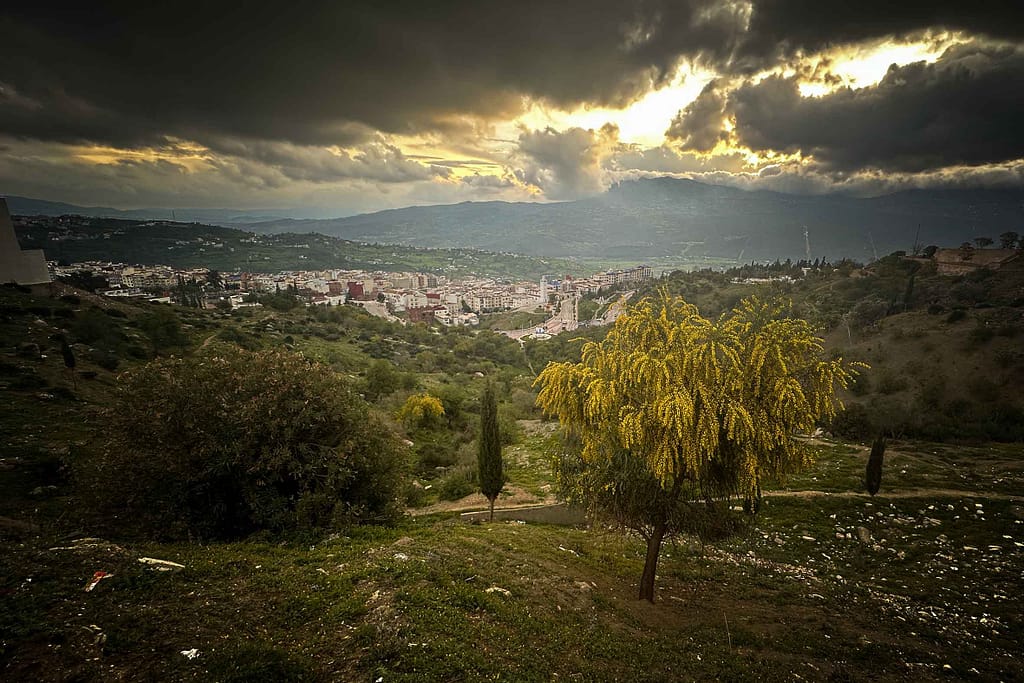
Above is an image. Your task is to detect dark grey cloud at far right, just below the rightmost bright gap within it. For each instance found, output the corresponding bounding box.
[726,46,1024,171]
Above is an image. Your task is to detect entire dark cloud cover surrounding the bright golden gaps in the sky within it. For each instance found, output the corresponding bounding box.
[0,0,1024,206]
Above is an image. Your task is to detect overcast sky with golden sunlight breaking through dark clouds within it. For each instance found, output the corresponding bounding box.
[0,0,1024,215]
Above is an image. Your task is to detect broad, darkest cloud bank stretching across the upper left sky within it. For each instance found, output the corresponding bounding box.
[0,0,742,150]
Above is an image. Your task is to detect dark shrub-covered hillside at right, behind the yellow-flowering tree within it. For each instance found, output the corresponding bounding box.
[647,254,1024,441]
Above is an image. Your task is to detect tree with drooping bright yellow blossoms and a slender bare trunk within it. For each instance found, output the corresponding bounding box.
[537,290,854,601]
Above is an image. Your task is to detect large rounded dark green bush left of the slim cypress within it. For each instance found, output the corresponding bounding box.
[78,344,408,539]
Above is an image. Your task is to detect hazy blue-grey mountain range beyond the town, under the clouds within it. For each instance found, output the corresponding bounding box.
[8,178,1024,262]
